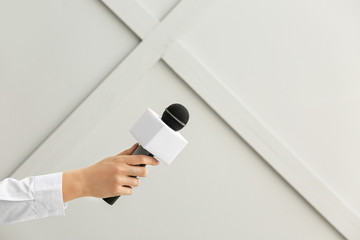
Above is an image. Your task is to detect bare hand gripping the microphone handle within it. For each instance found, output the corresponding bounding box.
[63,144,159,202]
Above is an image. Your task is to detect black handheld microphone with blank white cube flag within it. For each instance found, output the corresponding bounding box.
[103,103,190,205]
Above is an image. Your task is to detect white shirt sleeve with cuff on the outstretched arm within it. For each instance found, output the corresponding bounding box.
[0,172,67,224]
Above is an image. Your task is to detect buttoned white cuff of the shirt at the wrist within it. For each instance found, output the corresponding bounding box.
[34,172,67,218]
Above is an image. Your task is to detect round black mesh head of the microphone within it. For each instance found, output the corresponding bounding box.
[161,103,189,131]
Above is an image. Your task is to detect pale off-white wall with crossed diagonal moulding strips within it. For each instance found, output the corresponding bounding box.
[0,0,360,239]
